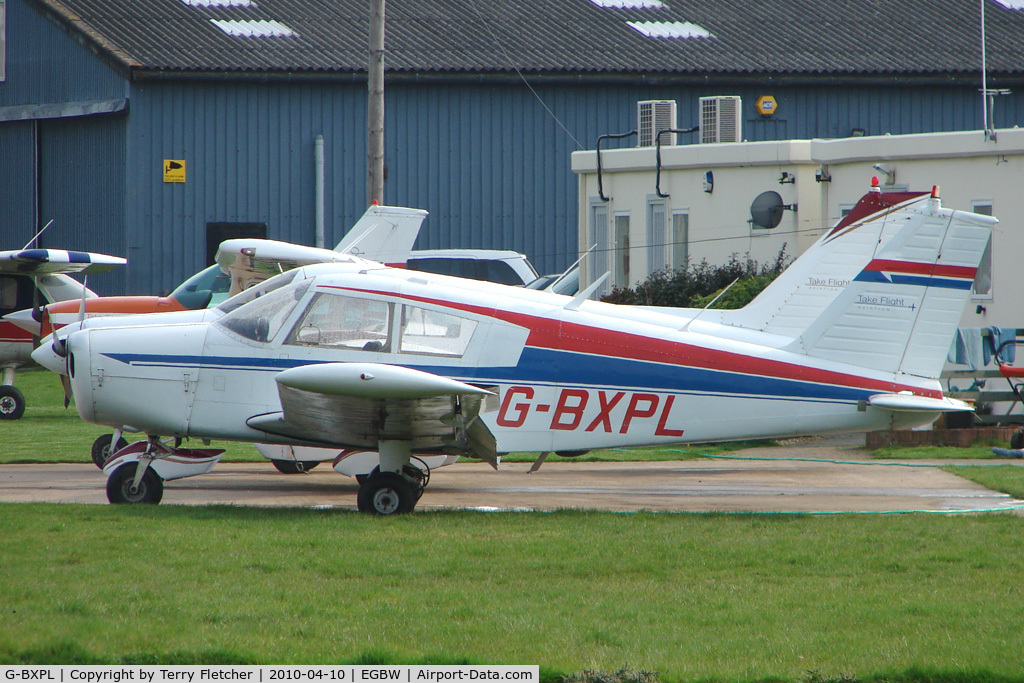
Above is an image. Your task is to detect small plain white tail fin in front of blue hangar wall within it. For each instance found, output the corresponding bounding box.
[334,204,427,265]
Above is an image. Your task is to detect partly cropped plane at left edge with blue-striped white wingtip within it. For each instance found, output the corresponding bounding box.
[0,245,127,420]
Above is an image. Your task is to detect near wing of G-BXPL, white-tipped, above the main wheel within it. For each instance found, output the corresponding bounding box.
[247,362,498,467]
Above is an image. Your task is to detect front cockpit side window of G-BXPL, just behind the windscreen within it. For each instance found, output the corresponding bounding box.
[285,292,394,353]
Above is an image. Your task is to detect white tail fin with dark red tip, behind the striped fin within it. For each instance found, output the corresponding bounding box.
[709,189,928,337]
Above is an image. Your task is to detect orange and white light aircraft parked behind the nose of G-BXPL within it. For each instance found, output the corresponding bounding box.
[4,204,427,336]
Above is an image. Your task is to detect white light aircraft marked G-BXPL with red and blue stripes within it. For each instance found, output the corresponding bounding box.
[36,190,995,514]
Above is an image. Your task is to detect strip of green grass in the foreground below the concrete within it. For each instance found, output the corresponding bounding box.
[0,505,1024,682]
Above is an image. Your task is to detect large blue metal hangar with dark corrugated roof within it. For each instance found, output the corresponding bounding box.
[0,0,1024,294]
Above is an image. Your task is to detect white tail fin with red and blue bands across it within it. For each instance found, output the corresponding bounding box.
[791,190,997,379]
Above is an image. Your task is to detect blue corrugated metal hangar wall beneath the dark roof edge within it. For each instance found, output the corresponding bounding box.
[121,76,1020,293]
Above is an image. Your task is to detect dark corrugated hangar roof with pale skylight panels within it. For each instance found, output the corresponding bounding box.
[26,0,1024,78]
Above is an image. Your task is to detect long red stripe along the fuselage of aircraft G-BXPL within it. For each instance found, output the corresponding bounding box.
[325,285,942,398]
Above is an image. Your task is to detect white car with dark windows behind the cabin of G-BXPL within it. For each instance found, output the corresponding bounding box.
[406,249,537,285]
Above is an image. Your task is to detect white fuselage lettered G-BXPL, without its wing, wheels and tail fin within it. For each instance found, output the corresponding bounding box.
[71,270,941,453]
